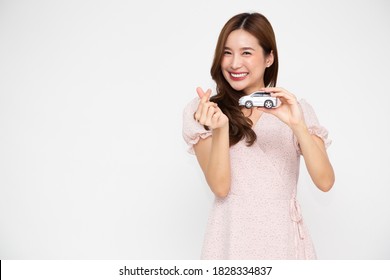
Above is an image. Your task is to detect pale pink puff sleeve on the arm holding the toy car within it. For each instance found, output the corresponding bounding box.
[294,99,332,154]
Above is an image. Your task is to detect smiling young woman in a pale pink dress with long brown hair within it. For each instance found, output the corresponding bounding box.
[183,13,334,259]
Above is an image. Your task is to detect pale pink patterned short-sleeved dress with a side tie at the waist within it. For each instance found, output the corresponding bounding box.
[183,98,330,259]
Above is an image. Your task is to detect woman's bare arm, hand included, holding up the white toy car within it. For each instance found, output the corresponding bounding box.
[260,88,335,192]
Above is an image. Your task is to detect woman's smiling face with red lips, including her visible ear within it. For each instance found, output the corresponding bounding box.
[221,29,273,94]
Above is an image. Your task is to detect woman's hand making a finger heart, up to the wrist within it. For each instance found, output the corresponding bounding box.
[194,87,229,129]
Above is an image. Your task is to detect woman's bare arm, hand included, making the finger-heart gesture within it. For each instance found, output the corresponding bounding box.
[194,88,230,197]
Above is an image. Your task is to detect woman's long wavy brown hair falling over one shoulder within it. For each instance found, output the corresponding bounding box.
[210,13,279,146]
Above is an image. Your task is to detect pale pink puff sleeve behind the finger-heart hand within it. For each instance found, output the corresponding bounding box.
[182,97,212,154]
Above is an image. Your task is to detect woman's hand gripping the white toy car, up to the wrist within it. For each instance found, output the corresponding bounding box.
[258,87,305,128]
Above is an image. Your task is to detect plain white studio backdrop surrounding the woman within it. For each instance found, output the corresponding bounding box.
[0,0,390,259]
